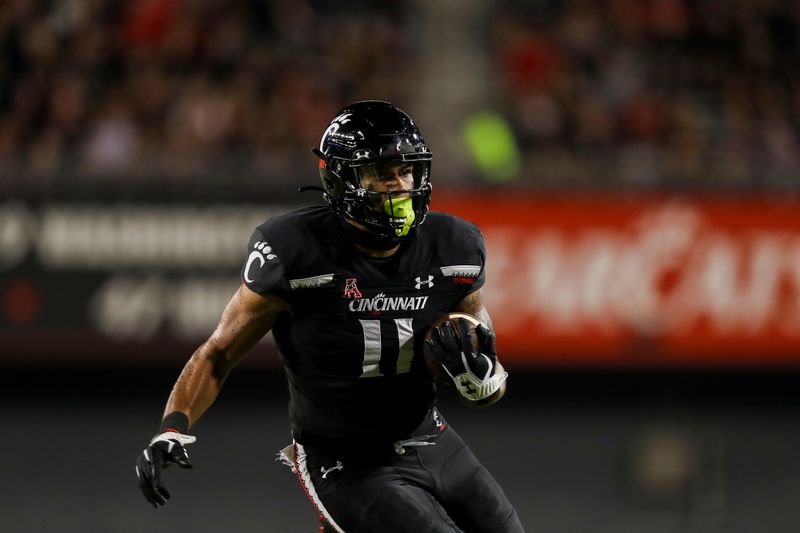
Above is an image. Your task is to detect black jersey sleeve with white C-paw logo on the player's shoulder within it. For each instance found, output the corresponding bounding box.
[242,224,289,296]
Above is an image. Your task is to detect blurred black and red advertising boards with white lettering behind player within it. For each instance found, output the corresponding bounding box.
[0,191,800,368]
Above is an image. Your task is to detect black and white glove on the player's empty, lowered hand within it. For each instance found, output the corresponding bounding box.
[136,431,197,509]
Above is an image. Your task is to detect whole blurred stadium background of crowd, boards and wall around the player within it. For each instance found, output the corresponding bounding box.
[0,0,800,533]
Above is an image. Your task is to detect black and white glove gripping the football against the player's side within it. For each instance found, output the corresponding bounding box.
[425,318,508,402]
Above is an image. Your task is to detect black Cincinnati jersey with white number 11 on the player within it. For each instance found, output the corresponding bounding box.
[242,207,485,447]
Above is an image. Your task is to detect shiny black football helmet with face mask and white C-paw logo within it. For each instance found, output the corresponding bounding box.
[313,100,432,238]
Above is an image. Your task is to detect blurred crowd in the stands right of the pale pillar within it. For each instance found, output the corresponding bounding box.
[490,0,800,190]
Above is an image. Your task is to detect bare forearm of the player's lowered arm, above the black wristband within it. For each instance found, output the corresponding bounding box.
[164,343,229,426]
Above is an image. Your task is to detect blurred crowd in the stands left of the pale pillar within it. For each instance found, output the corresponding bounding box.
[0,0,418,191]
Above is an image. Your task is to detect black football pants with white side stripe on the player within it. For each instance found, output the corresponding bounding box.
[295,413,524,533]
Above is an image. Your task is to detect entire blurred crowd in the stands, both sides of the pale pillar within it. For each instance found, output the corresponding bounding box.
[0,0,800,189]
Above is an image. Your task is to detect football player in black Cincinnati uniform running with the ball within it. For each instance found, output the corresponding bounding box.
[136,101,523,533]
